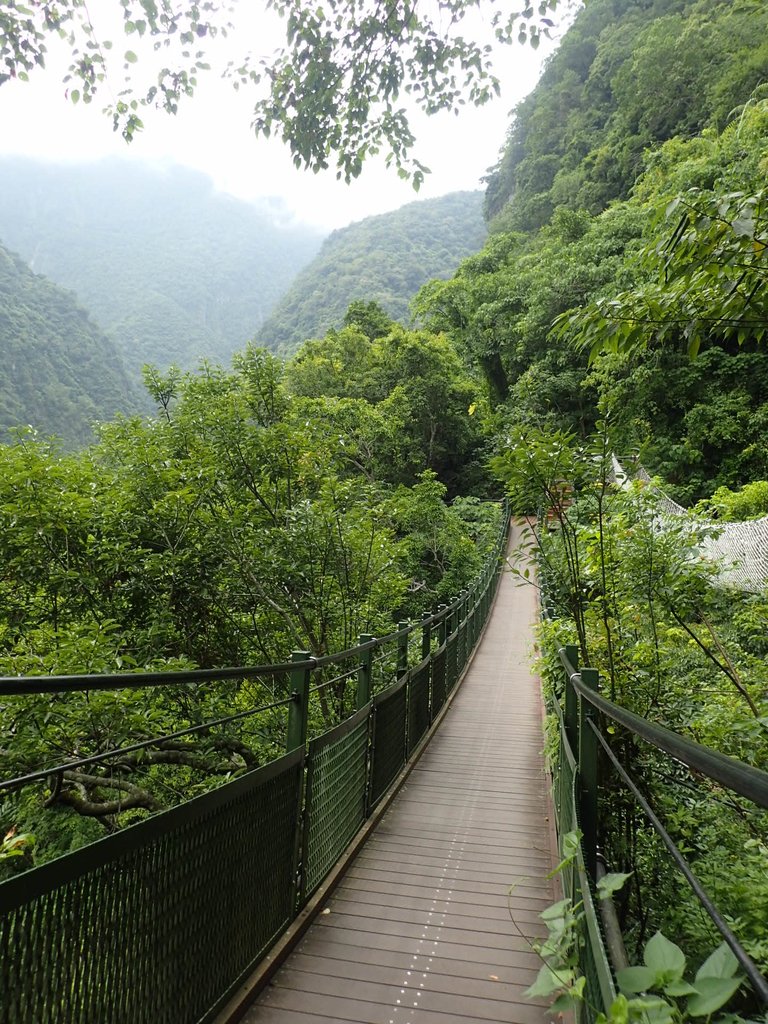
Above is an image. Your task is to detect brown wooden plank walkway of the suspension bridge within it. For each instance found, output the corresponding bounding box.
[243,528,555,1024]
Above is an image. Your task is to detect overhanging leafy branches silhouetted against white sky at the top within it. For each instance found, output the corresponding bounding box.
[0,0,557,188]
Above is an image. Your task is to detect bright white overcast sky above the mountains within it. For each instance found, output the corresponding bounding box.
[0,0,551,229]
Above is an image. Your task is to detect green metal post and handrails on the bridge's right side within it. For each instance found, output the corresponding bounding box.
[549,646,768,1022]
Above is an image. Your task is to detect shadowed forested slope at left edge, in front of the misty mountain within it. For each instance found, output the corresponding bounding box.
[0,246,146,445]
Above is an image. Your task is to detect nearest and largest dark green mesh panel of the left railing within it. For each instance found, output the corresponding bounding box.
[0,753,302,1024]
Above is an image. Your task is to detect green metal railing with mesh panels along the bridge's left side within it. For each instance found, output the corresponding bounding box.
[0,508,509,1024]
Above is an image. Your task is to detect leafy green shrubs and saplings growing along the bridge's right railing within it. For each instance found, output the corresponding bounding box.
[505,422,768,978]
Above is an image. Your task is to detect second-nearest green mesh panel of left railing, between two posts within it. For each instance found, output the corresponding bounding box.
[301,705,371,899]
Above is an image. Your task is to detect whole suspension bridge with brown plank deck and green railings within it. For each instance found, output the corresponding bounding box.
[0,512,768,1024]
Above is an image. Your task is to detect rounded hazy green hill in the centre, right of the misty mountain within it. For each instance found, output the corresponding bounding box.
[258,191,485,351]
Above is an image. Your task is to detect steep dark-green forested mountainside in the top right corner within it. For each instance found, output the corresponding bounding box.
[485,0,768,230]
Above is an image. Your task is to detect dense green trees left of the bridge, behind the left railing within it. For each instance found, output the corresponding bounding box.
[0,321,499,856]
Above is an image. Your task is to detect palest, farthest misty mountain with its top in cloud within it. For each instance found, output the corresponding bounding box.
[0,159,321,371]
